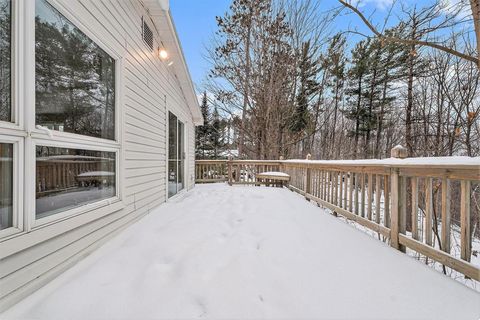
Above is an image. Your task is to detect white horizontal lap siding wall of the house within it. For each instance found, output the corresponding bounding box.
[0,0,195,310]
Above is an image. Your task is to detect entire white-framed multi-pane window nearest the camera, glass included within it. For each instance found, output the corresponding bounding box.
[0,0,124,236]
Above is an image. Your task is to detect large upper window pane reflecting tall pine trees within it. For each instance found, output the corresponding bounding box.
[34,0,115,140]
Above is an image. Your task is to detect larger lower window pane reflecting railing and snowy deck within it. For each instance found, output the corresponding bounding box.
[35,146,116,219]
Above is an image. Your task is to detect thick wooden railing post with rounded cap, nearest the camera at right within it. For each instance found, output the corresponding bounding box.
[390,146,407,252]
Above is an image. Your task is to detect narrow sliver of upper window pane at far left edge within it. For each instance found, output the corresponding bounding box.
[0,0,12,121]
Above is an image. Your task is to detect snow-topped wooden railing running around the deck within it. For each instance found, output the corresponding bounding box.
[196,146,480,281]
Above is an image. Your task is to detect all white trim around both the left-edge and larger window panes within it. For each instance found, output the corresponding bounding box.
[0,0,126,242]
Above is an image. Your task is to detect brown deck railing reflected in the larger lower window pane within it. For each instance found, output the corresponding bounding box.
[36,156,115,197]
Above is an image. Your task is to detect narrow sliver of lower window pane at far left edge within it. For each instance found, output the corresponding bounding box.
[0,143,13,230]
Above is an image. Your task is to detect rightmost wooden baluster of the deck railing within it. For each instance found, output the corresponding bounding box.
[460,180,472,261]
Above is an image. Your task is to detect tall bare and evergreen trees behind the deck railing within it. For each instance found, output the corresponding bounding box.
[200,0,480,159]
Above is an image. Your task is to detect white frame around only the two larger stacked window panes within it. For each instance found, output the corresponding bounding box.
[24,0,125,232]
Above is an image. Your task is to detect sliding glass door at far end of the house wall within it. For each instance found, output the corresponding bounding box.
[168,112,185,197]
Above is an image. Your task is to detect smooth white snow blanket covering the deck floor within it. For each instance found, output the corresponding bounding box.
[0,184,480,320]
